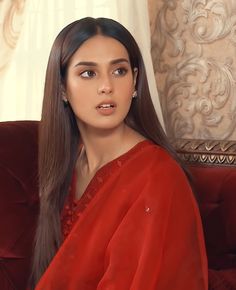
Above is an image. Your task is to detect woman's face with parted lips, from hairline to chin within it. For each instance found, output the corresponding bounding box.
[66,35,137,134]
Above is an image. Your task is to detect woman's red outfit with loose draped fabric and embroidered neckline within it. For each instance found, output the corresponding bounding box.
[36,141,207,290]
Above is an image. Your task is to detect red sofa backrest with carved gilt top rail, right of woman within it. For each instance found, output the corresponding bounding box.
[174,140,236,270]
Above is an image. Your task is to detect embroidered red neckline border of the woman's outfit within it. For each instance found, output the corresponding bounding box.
[61,139,152,239]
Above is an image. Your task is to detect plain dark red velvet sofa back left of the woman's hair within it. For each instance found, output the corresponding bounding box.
[0,121,38,290]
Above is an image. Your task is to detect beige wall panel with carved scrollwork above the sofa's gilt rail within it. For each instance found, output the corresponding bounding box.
[149,0,236,140]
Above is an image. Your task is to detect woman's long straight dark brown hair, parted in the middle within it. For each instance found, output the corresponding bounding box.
[31,17,183,288]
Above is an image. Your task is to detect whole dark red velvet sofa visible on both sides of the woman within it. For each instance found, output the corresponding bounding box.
[0,121,236,290]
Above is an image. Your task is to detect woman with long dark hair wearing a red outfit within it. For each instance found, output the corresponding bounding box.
[32,17,207,290]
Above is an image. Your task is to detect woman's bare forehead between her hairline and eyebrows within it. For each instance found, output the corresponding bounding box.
[71,35,129,64]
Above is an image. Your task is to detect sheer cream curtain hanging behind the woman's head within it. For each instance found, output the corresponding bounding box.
[0,0,163,128]
